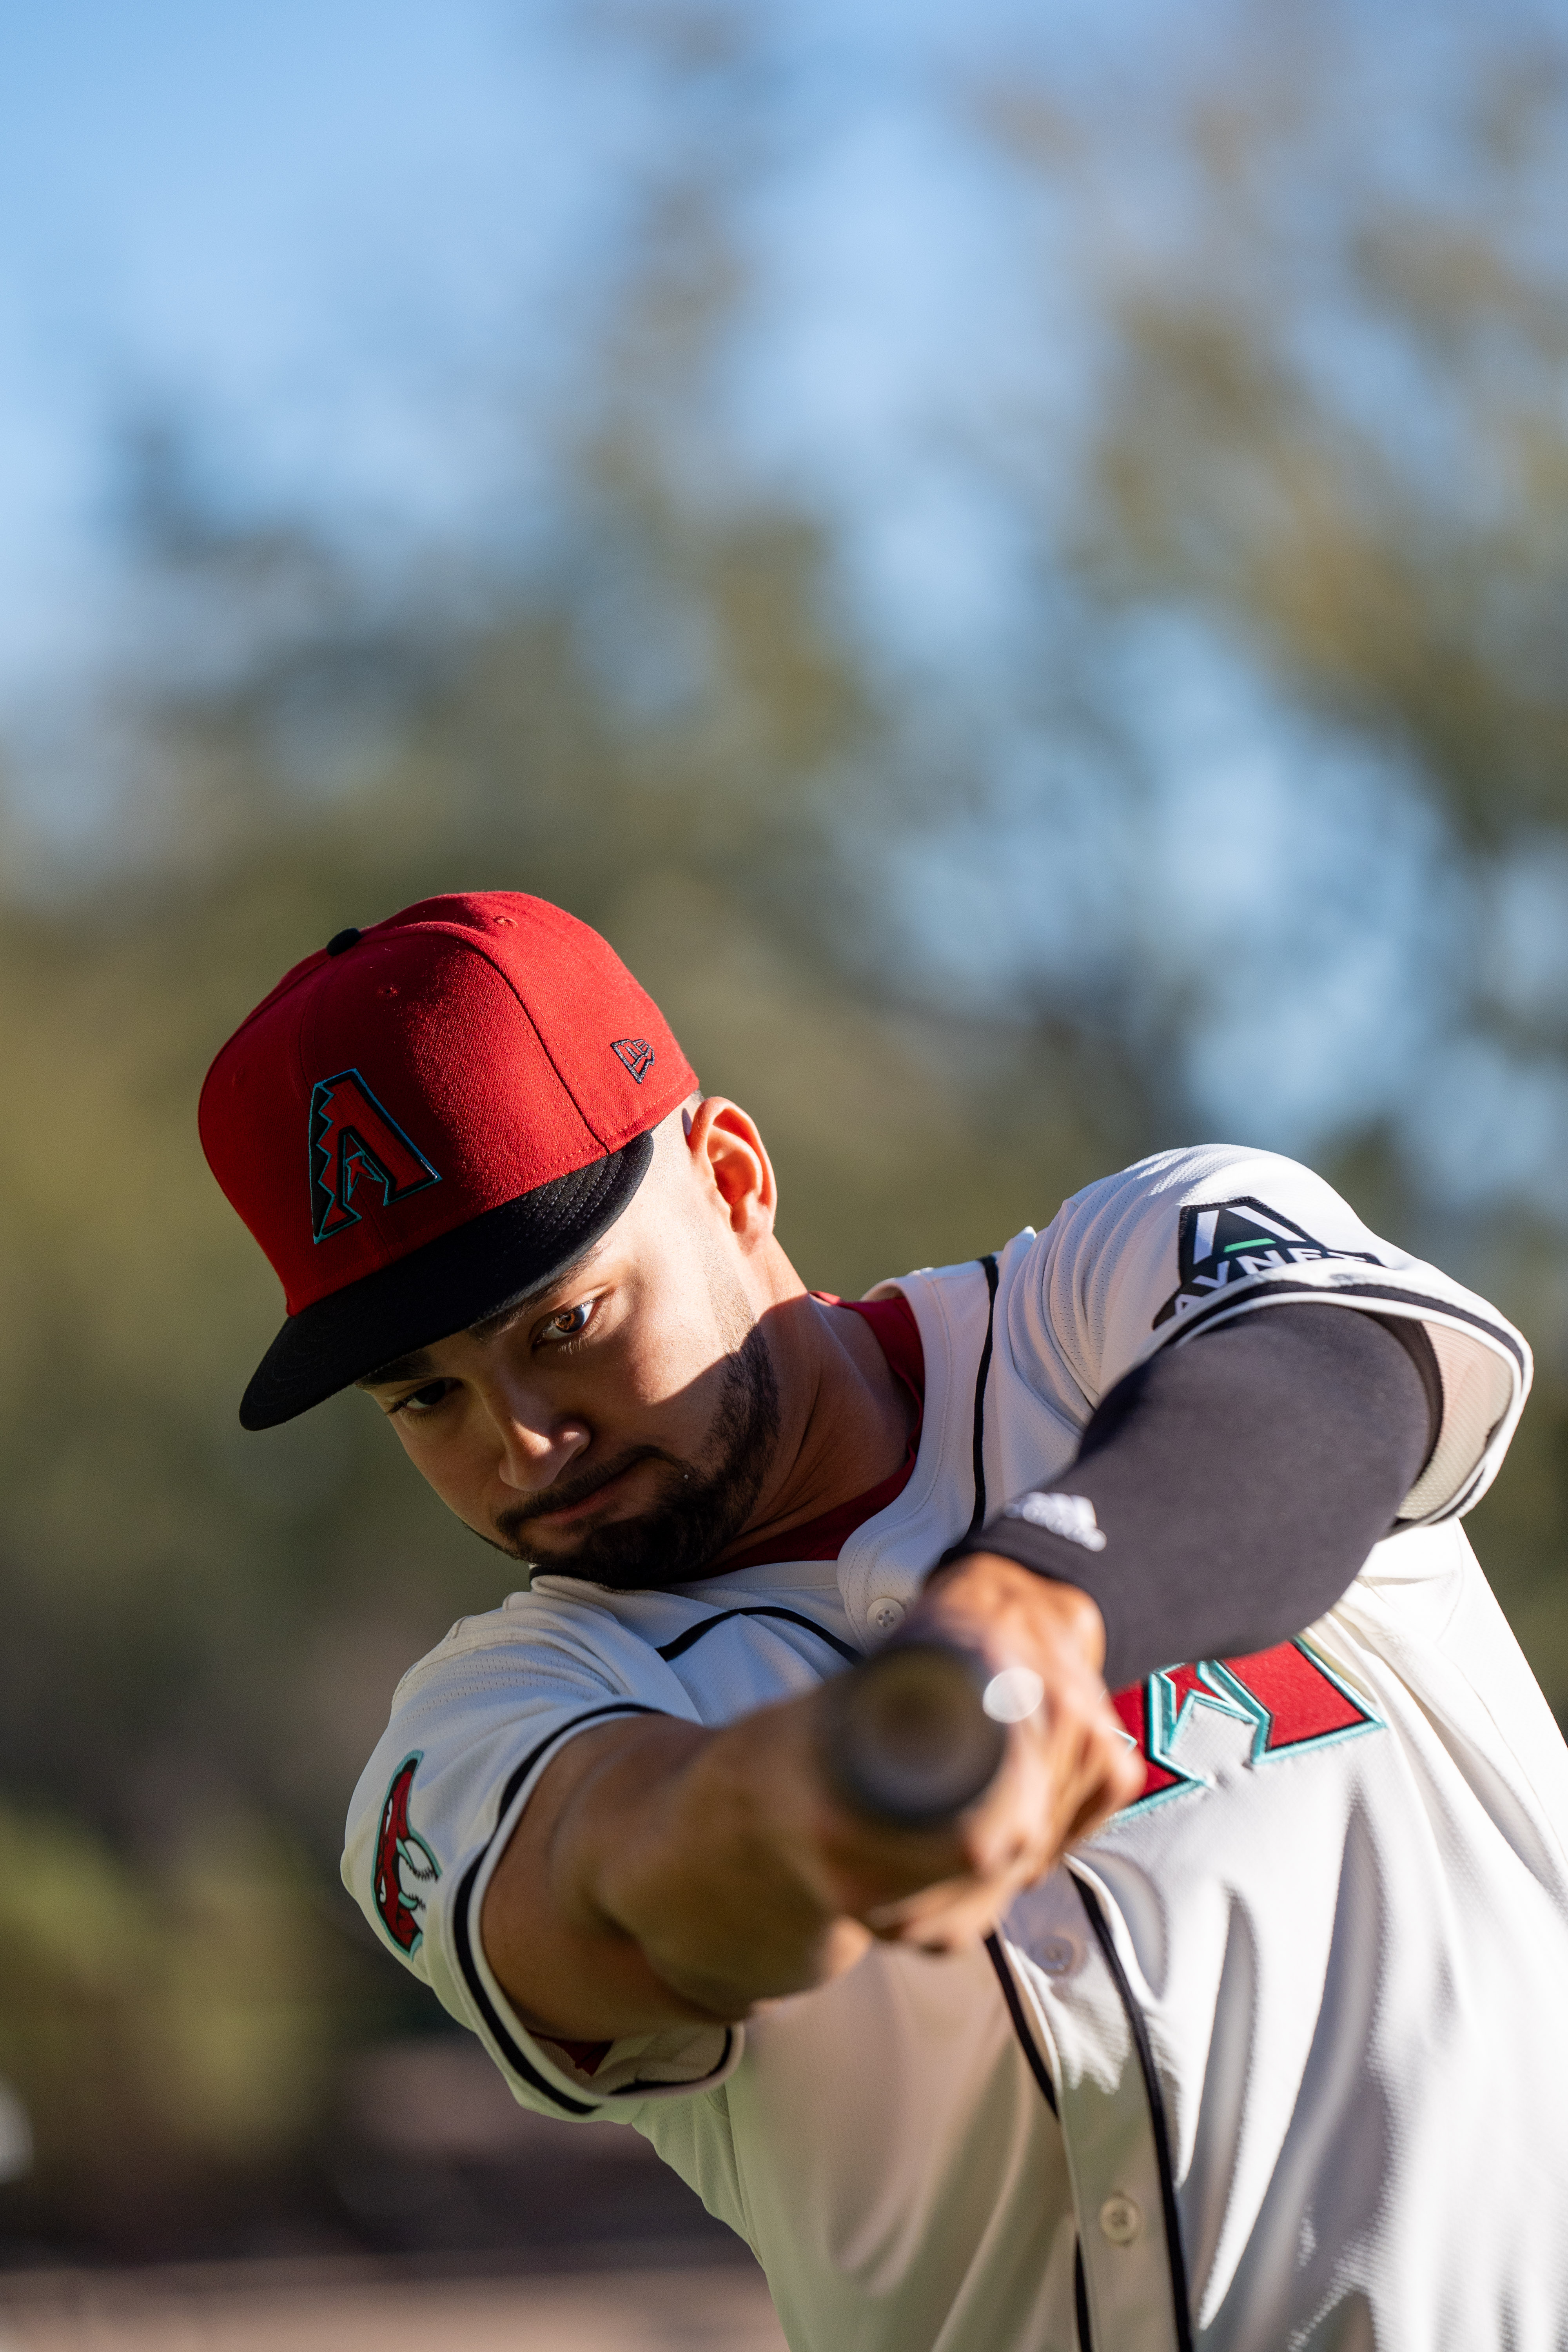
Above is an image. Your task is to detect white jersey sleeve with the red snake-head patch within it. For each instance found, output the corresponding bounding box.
[343,1592,743,2119]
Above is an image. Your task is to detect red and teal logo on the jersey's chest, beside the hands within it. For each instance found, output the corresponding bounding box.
[1112,1642,1382,1811]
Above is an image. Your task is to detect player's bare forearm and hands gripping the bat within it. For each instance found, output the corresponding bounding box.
[482,1555,1143,2039]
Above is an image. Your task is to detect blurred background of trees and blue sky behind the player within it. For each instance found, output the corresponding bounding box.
[0,0,1568,2296]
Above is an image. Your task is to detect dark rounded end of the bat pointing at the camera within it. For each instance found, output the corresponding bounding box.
[823,1639,1006,1830]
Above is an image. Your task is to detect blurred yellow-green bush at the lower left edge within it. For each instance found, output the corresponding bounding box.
[0,1811,346,2251]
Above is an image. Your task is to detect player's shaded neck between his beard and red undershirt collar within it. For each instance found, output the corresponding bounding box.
[715,1289,915,1569]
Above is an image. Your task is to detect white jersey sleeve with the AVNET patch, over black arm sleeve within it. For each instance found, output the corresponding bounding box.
[1013,1145,1530,1526]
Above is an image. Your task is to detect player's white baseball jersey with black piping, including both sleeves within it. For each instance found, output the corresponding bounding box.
[343,1148,1568,2352]
